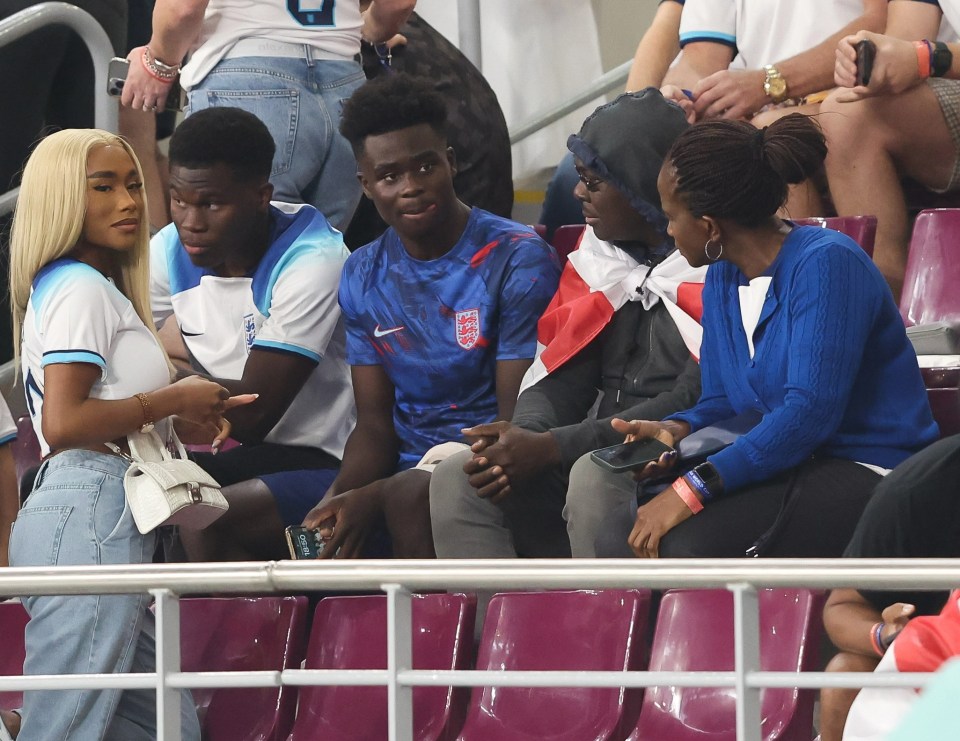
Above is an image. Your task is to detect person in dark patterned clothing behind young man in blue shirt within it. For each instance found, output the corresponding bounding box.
[344,7,513,249]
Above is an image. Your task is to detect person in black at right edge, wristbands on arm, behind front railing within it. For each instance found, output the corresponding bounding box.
[820,435,960,741]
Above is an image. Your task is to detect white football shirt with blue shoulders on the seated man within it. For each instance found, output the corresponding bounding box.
[150,203,356,458]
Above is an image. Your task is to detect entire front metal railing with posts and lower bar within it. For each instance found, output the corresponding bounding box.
[0,559,960,741]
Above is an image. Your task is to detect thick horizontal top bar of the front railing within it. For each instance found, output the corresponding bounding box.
[0,558,960,595]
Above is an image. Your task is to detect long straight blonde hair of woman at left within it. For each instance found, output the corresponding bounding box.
[10,129,154,367]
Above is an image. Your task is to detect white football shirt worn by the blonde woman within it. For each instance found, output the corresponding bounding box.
[21,258,170,455]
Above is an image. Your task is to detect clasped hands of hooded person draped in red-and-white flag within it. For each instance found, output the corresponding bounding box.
[463,422,560,502]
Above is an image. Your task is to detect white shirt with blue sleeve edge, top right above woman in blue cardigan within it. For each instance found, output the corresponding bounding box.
[680,0,863,69]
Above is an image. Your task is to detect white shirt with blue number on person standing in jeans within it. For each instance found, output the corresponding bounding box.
[180,0,363,90]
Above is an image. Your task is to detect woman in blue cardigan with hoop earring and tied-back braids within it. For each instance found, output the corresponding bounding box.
[615,114,938,558]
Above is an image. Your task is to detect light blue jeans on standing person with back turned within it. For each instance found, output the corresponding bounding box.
[187,57,365,231]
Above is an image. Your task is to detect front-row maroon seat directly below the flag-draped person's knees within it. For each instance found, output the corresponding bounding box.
[459,590,650,741]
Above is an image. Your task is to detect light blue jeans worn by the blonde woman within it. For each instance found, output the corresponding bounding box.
[10,450,200,741]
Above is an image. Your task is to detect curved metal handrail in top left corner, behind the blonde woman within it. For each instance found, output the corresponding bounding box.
[0,3,119,216]
